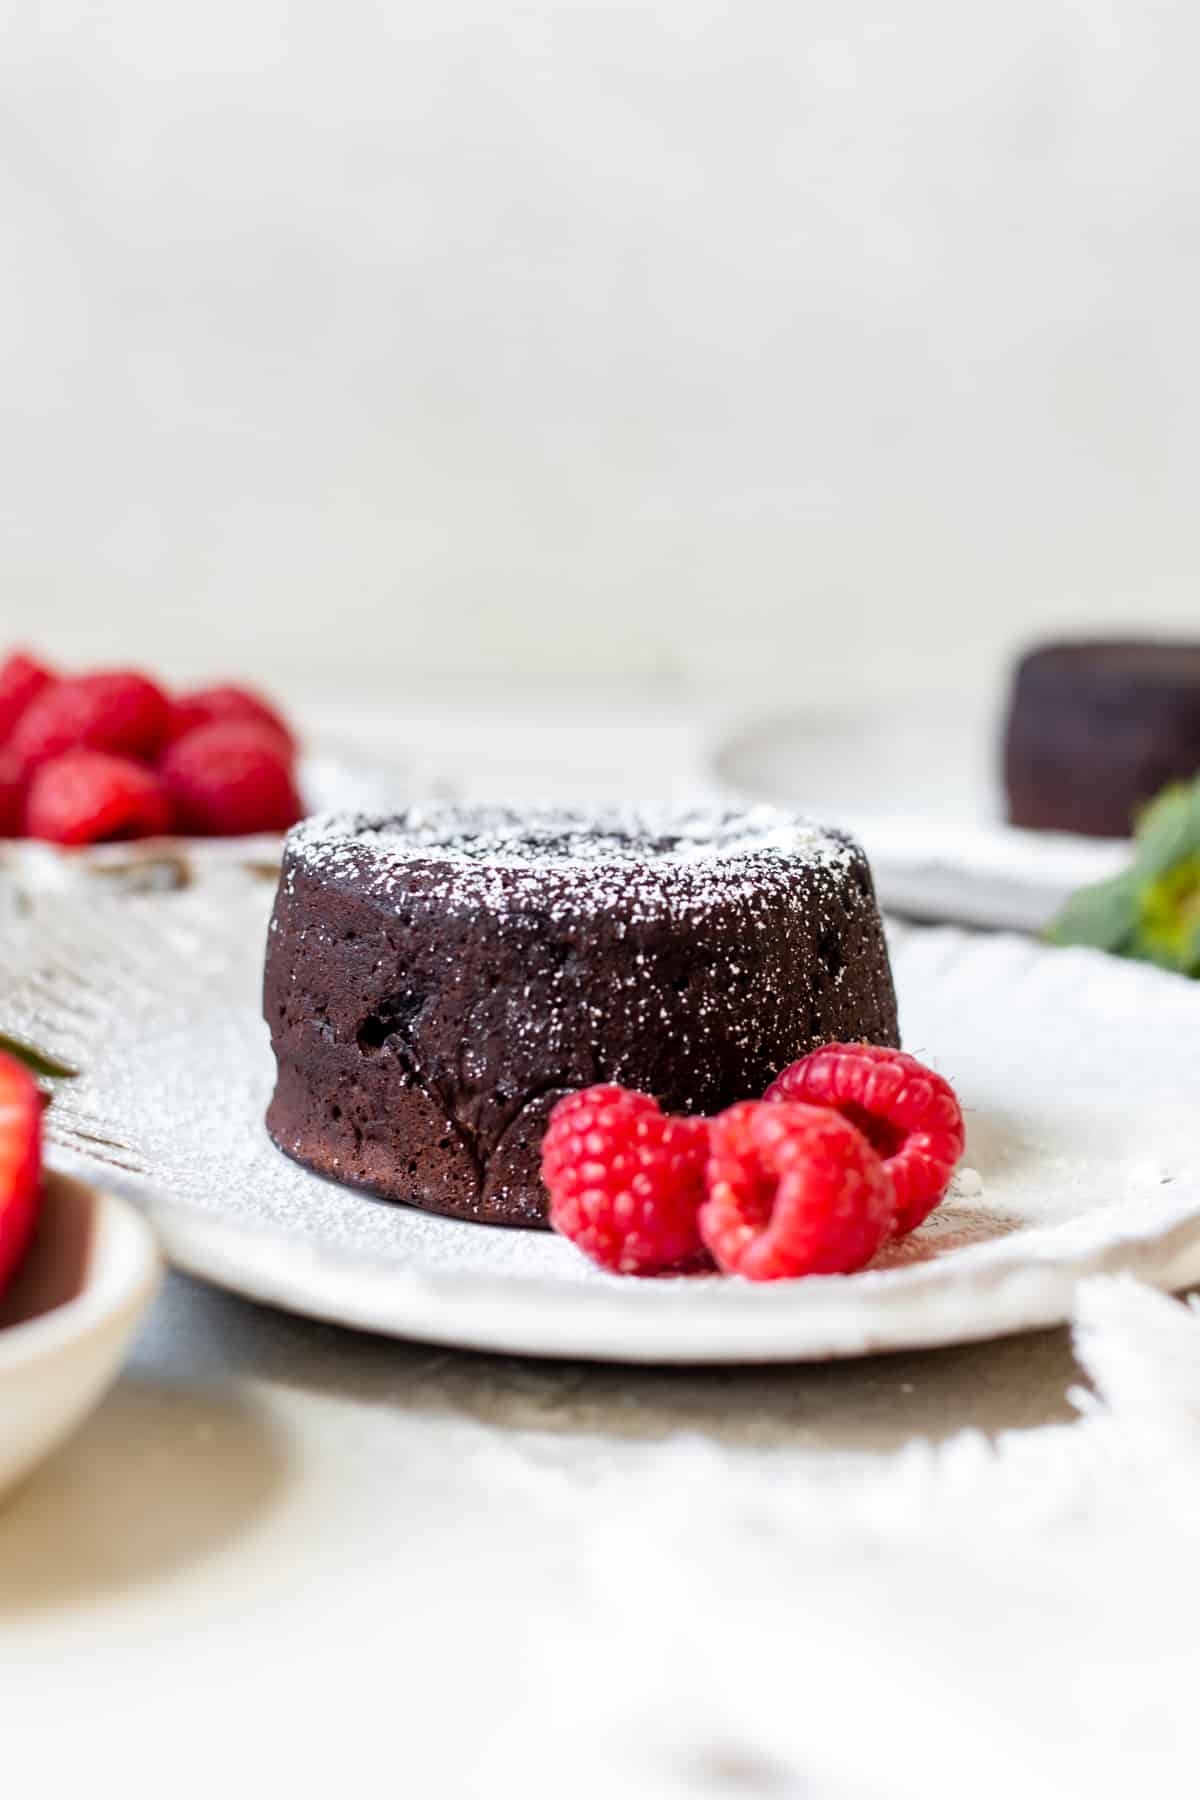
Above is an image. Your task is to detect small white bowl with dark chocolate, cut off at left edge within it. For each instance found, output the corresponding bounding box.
[0,1172,162,1496]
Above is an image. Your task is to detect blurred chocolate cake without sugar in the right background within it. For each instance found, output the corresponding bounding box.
[1004,639,1200,837]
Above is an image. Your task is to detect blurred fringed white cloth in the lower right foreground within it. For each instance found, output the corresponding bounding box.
[479,1278,1200,1800]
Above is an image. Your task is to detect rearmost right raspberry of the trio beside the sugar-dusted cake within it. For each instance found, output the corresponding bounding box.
[765,1044,966,1237]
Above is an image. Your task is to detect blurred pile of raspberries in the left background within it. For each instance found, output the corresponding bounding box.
[0,652,302,844]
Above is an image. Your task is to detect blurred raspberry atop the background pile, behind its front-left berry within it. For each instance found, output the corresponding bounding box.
[11,670,167,776]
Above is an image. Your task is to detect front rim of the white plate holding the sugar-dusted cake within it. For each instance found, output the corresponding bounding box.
[50,1147,1200,1366]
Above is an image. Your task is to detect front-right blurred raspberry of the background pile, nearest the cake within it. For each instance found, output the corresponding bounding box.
[162,725,304,837]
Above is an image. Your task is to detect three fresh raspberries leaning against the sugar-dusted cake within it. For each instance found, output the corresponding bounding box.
[542,1044,964,1282]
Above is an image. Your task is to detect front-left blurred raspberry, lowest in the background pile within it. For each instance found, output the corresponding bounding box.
[25,751,171,844]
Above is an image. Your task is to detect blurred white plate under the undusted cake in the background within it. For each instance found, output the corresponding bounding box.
[711,697,1128,931]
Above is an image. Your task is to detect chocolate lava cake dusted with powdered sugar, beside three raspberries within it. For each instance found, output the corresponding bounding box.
[264,808,900,1226]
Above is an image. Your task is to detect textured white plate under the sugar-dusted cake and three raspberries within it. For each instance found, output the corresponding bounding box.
[0,877,1200,1363]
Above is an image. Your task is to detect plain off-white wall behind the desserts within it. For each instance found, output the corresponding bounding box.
[0,0,1200,697]
